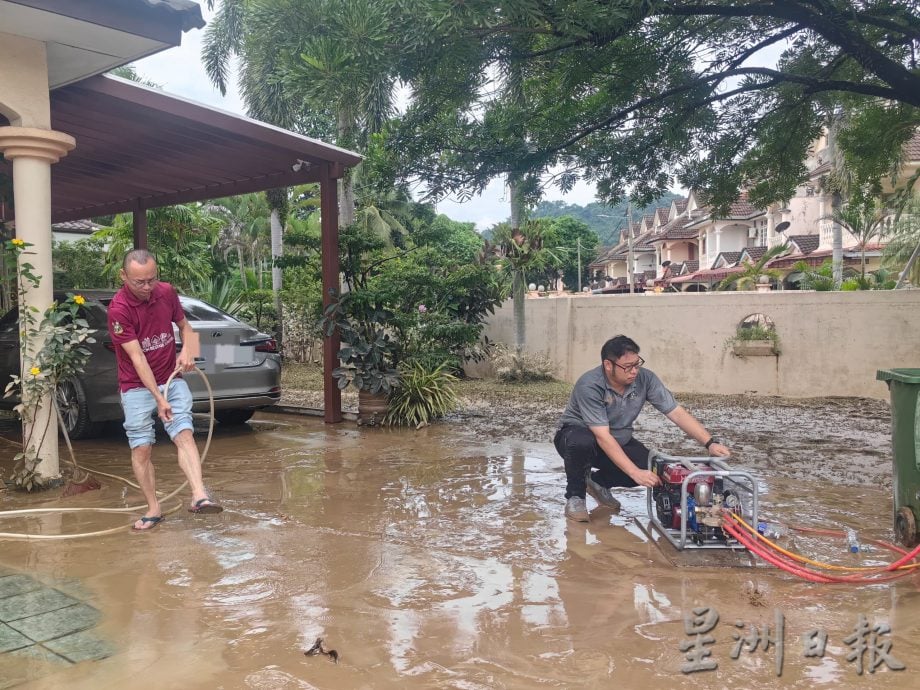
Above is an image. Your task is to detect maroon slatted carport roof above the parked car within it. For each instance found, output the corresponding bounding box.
[0,75,361,223]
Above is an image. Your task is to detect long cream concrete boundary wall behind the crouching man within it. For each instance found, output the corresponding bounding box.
[470,290,920,399]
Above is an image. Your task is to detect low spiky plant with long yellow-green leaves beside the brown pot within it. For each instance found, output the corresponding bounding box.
[383,361,457,429]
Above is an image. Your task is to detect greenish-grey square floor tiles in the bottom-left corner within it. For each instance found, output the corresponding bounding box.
[0,567,113,688]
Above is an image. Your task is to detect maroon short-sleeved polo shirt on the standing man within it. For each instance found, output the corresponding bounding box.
[109,283,185,393]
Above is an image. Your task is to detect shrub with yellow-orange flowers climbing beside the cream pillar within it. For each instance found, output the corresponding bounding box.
[4,239,95,491]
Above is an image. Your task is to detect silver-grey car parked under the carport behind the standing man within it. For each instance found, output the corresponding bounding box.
[0,290,281,439]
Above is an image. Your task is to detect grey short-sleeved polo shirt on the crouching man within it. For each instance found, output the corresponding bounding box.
[559,366,677,445]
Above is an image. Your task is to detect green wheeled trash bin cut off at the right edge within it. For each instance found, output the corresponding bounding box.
[875,369,920,546]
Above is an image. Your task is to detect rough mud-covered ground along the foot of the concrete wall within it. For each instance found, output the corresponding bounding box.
[282,365,891,489]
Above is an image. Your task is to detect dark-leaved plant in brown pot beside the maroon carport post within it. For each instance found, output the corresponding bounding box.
[321,298,400,425]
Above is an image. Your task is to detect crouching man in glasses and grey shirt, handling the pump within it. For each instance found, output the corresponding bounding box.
[553,335,731,522]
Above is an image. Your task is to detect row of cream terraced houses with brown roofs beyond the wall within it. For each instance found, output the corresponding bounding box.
[589,127,920,292]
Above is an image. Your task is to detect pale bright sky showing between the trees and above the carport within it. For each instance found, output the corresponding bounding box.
[134,8,595,231]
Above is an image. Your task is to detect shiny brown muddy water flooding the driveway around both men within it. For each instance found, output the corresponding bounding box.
[0,410,920,690]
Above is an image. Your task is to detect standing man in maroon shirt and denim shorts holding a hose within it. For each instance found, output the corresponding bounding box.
[109,249,223,530]
